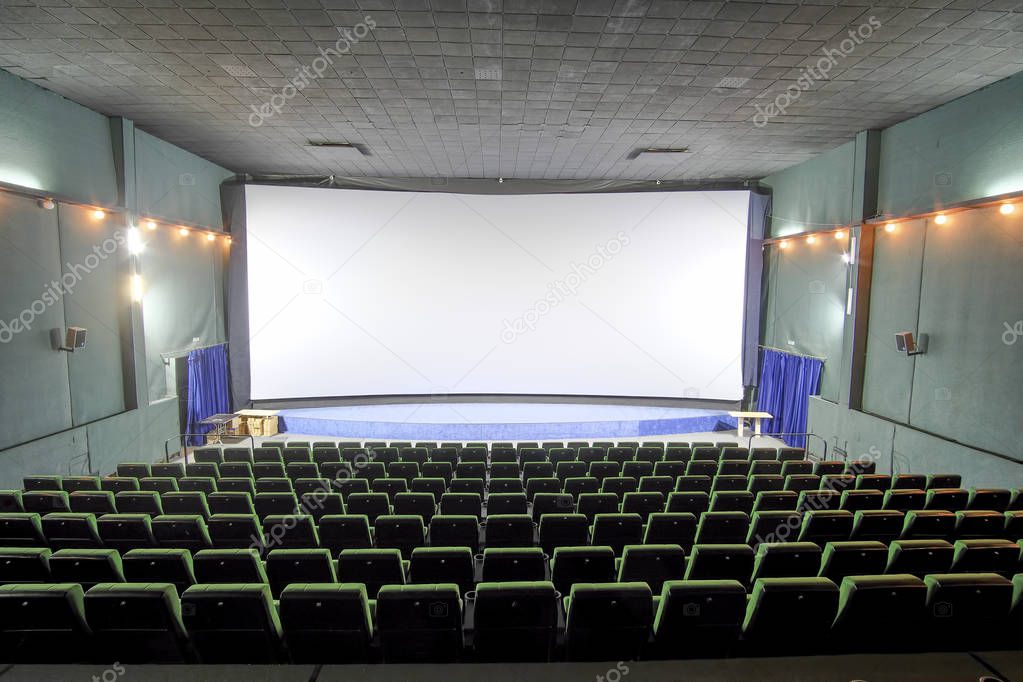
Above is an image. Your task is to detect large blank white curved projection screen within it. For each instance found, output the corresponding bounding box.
[246,185,749,401]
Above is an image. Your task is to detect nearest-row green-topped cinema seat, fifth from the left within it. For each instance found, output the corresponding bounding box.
[376,583,462,663]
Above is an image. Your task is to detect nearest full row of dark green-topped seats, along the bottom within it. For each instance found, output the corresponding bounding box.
[0,573,1023,664]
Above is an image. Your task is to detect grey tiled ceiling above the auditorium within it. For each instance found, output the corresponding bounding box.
[0,0,1023,181]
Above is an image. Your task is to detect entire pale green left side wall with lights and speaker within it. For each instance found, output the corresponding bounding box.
[0,71,231,488]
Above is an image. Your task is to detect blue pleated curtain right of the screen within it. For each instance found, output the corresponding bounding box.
[757,349,825,448]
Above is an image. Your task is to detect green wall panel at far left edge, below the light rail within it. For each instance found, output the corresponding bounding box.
[0,192,72,448]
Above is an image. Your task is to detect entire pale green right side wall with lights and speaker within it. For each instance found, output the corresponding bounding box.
[763,75,1023,487]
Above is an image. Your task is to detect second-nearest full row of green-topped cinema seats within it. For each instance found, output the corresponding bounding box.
[0,540,1023,596]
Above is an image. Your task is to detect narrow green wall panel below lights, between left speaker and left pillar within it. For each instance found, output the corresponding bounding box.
[58,204,131,425]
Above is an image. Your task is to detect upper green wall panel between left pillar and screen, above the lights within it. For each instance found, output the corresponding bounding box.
[135,129,234,229]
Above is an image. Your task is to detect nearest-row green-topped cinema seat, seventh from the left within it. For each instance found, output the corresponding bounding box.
[565,582,654,661]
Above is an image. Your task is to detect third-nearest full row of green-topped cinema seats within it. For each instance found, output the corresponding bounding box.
[7,510,1023,556]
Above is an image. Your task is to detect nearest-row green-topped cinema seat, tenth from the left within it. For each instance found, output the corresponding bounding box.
[830,574,927,653]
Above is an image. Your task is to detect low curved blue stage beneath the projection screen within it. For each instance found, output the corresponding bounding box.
[279,402,736,441]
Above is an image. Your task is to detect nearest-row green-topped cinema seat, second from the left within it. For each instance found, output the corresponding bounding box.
[85,583,191,665]
